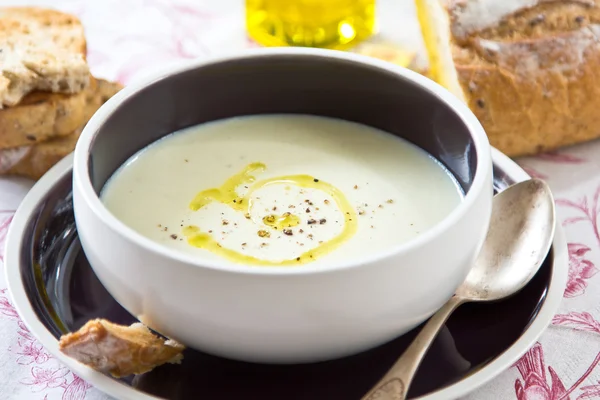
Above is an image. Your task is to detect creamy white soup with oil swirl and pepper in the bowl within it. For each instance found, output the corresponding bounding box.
[101,114,463,266]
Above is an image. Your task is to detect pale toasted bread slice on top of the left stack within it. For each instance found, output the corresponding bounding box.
[0,7,90,108]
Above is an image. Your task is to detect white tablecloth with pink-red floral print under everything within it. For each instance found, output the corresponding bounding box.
[0,0,600,400]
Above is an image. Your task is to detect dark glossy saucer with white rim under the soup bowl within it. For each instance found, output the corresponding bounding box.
[5,150,568,400]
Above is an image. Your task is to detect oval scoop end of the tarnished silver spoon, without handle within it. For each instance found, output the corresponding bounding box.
[456,179,555,301]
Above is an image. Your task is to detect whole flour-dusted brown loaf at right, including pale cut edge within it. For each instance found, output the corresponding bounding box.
[415,0,600,156]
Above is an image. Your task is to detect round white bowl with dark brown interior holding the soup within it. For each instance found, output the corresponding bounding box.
[73,49,492,363]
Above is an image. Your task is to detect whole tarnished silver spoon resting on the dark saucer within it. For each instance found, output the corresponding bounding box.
[362,179,555,400]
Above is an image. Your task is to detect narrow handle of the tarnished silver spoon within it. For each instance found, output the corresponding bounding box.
[361,296,465,400]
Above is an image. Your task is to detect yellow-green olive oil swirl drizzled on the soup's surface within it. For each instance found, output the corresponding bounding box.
[182,162,358,266]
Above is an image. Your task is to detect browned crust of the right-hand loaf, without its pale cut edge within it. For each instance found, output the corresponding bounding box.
[453,1,600,156]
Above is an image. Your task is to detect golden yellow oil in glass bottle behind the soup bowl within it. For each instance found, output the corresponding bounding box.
[246,0,375,50]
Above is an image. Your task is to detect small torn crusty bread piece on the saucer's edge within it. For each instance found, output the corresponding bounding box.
[58,319,184,378]
